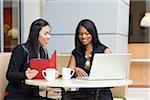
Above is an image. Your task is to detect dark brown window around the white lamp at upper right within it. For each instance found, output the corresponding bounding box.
[129,0,150,43]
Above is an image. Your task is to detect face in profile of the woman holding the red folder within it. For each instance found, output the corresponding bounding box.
[38,25,51,46]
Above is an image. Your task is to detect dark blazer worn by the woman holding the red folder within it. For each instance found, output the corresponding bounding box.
[6,43,48,95]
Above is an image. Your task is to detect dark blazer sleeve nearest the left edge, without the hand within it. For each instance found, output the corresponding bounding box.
[6,46,27,83]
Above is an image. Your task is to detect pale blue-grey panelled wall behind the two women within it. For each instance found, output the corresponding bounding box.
[44,0,129,53]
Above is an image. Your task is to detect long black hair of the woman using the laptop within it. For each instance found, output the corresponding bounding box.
[75,19,101,51]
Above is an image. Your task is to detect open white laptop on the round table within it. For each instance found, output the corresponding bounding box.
[77,53,131,80]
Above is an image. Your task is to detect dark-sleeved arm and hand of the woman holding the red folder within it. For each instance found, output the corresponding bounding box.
[6,46,38,83]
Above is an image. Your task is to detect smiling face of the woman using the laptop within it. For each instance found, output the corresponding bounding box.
[79,26,92,46]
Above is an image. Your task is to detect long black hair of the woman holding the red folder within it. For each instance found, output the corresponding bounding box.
[27,19,50,55]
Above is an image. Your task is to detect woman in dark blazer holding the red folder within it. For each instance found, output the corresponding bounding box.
[4,19,58,100]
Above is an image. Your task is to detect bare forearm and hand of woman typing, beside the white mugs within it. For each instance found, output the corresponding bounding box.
[68,55,88,76]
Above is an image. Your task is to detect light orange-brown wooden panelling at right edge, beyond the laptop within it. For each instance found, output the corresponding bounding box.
[128,43,150,87]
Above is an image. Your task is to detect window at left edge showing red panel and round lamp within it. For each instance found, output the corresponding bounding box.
[4,0,20,52]
